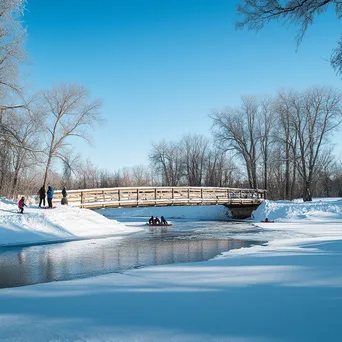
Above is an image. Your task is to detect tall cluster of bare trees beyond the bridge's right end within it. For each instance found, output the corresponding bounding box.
[211,87,342,201]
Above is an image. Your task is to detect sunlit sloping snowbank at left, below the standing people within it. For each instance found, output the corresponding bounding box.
[0,198,138,246]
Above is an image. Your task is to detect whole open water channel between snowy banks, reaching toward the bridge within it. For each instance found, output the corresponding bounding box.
[0,217,265,288]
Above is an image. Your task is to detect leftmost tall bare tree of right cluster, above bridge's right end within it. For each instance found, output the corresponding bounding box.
[210,96,260,188]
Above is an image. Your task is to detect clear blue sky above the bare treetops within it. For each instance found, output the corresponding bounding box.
[24,0,341,170]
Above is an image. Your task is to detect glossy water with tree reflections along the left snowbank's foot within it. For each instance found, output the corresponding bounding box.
[0,232,262,288]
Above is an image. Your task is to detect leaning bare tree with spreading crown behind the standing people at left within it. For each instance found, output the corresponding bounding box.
[42,84,101,185]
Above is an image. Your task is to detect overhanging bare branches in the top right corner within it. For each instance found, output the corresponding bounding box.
[236,0,342,75]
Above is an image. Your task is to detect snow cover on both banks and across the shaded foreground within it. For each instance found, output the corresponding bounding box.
[0,199,342,342]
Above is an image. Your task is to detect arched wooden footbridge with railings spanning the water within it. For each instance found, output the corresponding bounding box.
[53,187,266,217]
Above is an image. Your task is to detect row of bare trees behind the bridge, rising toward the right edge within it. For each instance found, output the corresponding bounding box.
[22,87,342,201]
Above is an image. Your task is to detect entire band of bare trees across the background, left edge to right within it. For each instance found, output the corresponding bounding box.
[0,0,342,201]
